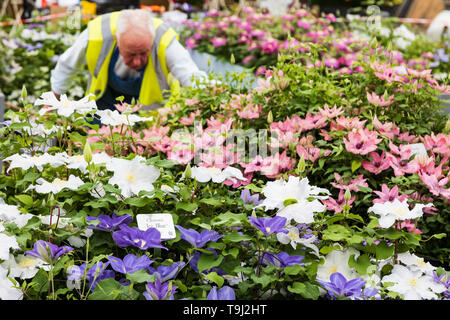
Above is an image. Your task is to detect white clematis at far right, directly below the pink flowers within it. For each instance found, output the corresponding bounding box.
[368,199,433,228]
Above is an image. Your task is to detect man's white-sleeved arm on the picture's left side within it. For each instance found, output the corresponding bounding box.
[50,29,88,99]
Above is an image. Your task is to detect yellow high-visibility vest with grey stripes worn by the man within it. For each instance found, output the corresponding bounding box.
[86,11,178,105]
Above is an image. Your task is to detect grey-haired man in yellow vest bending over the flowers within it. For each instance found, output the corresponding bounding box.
[50,9,206,110]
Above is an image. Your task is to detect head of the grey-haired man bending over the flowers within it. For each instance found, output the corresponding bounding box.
[116,9,155,70]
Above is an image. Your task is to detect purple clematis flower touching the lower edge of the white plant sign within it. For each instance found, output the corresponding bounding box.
[113,225,168,250]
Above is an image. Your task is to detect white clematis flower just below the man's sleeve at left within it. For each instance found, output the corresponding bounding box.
[34,92,97,117]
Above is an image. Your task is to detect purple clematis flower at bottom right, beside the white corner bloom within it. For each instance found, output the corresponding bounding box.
[317,272,366,299]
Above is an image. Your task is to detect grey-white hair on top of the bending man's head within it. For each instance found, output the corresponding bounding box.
[116,9,155,38]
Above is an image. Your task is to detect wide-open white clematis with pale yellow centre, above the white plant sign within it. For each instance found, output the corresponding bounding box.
[106,156,160,198]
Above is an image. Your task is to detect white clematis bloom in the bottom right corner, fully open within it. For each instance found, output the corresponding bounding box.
[381,264,446,300]
